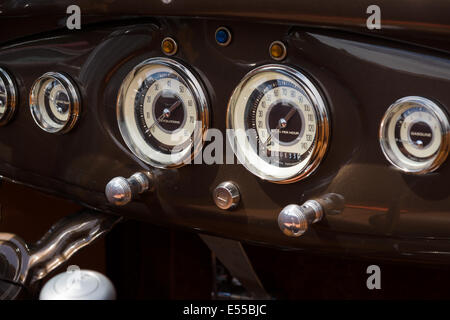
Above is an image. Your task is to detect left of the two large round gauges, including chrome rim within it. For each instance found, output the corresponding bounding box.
[117,58,209,168]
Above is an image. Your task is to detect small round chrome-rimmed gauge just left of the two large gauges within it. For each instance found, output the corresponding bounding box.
[30,72,80,133]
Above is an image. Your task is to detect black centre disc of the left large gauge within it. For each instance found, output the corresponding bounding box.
[155,92,185,131]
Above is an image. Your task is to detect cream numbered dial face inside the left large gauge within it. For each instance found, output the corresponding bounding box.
[135,72,197,154]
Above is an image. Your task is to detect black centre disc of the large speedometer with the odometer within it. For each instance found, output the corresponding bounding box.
[268,102,303,143]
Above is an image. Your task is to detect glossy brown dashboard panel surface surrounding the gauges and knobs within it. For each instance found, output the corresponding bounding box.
[0,18,450,261]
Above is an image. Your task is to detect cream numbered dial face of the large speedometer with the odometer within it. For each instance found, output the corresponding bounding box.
[246,79,317,167]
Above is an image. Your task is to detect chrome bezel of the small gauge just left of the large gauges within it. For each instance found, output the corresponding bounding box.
[29,72,81,134]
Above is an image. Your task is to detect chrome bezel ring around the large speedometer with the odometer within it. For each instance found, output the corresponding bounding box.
[226,64,331,184]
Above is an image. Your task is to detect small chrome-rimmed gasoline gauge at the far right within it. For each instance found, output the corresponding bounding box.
[380,96,450,174]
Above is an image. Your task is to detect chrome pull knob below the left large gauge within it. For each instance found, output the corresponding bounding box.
[105,172,154,206]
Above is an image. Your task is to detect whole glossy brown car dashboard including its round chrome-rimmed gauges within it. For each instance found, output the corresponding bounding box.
[0,1,450,263]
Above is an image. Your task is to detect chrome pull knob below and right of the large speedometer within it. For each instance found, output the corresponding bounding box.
[278,193,344,237]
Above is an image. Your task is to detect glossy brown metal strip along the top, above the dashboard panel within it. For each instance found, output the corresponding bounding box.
[0,0,450,51]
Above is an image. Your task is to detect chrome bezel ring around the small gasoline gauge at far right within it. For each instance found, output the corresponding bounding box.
[378,96,450,175]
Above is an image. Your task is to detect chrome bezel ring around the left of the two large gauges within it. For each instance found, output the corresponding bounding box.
[116,57,209,169]
